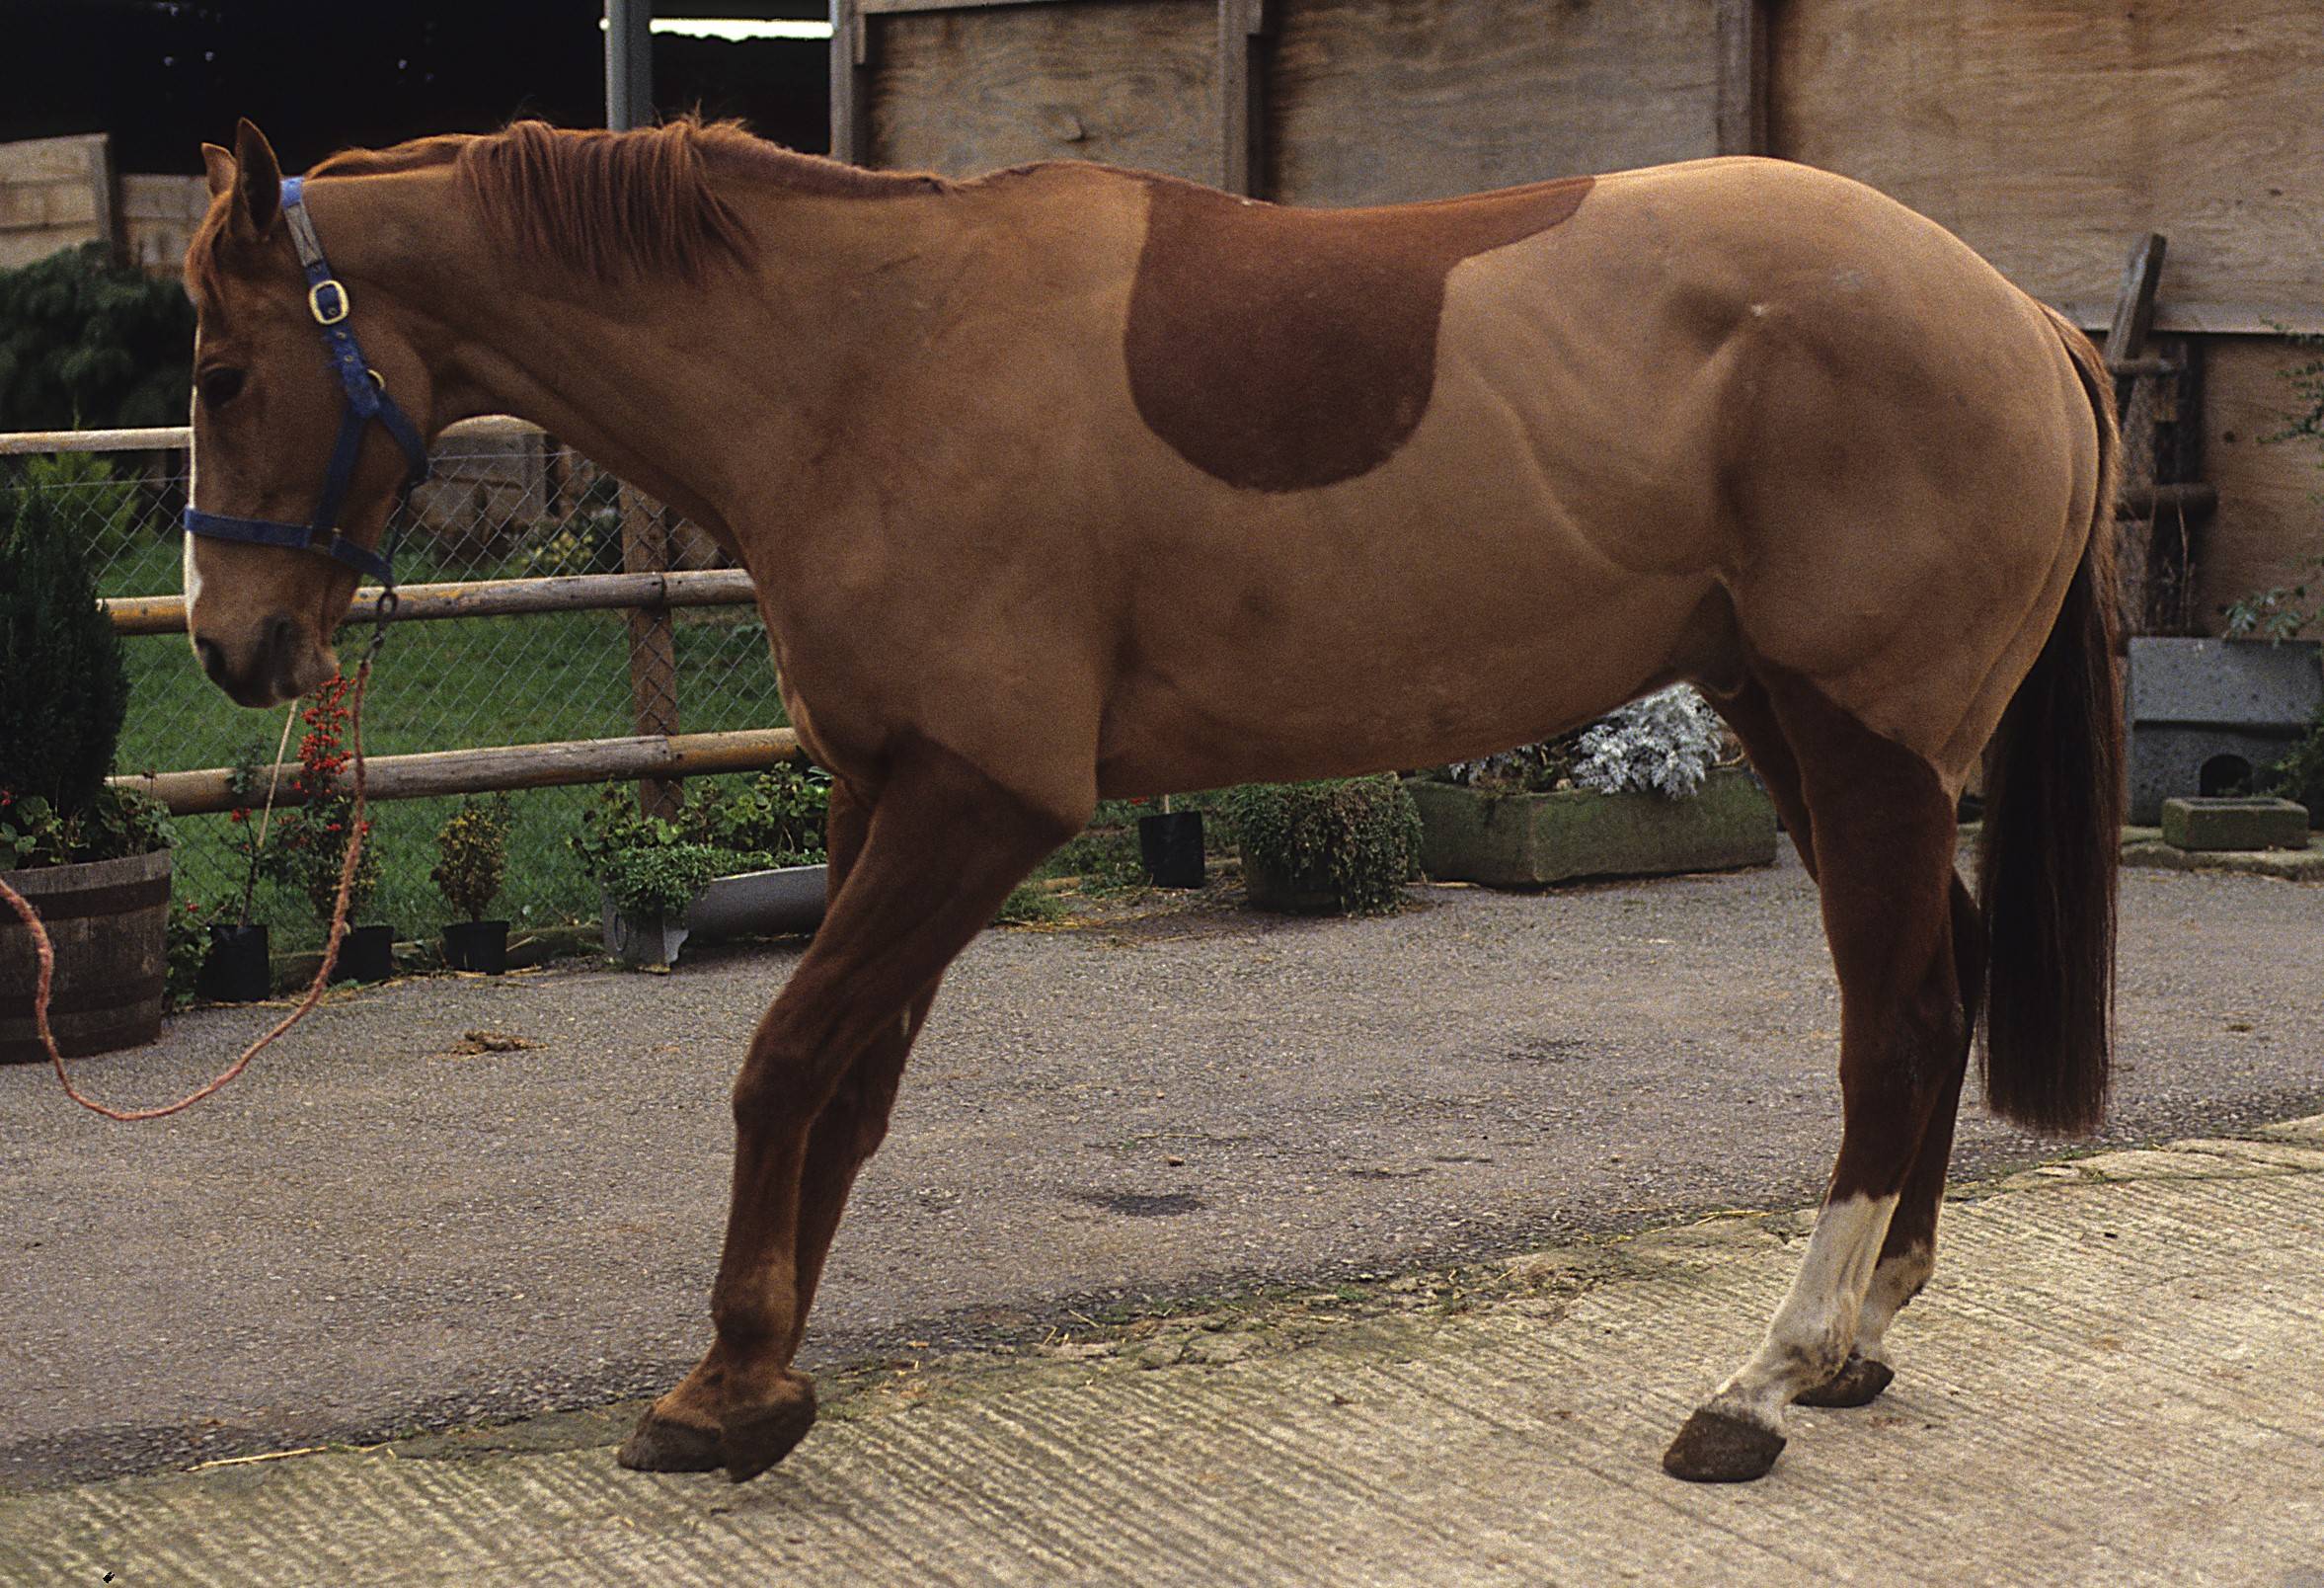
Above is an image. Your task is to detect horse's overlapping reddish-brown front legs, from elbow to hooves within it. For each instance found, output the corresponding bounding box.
[621,747,1071,1481]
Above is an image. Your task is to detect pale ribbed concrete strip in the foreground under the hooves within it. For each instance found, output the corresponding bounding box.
[0,1116,2324,1588]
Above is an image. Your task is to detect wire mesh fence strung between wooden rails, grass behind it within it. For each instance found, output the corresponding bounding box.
[0,433,788,946]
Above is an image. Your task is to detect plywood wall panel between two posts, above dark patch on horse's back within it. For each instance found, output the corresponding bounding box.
[1265,0,1718,204]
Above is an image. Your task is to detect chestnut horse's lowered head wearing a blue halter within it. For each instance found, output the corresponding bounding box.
[186,120,427,707]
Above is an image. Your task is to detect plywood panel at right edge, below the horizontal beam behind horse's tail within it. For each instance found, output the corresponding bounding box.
[2197,337,2324,639]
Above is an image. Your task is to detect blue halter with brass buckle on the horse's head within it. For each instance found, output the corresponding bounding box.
[186,177,427,591]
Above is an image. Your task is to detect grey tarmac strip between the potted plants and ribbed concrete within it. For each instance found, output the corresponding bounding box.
[0,858,2324,1488]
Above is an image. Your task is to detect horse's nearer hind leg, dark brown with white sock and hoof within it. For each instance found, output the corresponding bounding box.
[1662,676,1969,1481]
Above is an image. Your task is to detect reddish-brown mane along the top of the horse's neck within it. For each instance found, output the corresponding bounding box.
[195,117,951,294]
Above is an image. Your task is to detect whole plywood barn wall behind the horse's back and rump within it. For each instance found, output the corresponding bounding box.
[834,0,2324,628]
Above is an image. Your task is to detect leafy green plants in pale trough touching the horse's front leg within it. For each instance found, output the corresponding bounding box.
[572,765,829,967]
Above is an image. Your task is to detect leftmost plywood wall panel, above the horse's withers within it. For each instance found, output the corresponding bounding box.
[865,0,1220,182]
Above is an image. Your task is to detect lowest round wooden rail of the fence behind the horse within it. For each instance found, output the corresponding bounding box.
[112,728,802,816]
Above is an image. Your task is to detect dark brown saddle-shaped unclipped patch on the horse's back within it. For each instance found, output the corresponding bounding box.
[1124,177,1591,491]
